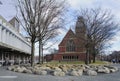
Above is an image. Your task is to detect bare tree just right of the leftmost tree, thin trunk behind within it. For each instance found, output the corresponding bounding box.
[34,0,65,63]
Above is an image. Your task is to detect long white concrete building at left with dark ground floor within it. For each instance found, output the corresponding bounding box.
[0,16,31,64]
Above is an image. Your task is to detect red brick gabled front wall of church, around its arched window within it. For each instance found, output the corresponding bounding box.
[47,29,86,61]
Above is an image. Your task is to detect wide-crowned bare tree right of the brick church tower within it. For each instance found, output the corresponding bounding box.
[78,8,118,64]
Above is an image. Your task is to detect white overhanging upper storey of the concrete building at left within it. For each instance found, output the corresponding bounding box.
[0,16,31,54]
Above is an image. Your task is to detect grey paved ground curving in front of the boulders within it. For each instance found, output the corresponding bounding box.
[0,64,120,81]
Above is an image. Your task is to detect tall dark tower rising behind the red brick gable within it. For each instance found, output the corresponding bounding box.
[75,16,86,39]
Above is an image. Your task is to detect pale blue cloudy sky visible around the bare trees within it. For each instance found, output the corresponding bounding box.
[0,0,120,55]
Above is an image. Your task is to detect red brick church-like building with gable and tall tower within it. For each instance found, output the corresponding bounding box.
[45,17,86,61]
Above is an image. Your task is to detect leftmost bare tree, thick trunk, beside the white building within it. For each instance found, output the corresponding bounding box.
[18,0,39,66]
